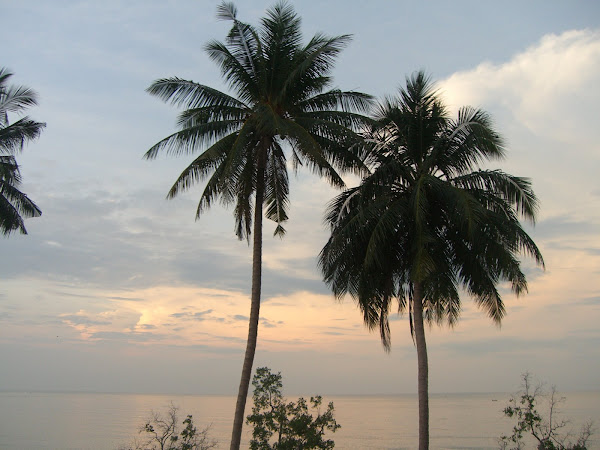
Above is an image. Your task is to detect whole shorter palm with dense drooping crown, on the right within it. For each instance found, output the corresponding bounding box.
[319,72,543,450]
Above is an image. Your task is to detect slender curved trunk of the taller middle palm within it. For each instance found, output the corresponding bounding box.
[229,148,266,450]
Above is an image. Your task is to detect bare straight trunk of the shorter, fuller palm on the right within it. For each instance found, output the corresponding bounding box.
[413,282,429,450]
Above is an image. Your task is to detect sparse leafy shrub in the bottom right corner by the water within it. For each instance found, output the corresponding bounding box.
[499,373,592,450]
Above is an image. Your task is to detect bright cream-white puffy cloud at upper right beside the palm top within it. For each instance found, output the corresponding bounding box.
[441,30,600,136]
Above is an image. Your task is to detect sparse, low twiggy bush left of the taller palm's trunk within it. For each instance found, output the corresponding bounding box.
[121,404,217,450]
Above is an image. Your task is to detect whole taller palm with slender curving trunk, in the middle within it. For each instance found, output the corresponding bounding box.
[145,3,371,449]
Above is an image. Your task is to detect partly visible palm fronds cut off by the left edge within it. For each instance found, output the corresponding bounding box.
[0,68,46,236]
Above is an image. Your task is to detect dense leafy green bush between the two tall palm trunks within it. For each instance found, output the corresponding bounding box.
[247,367,340,450]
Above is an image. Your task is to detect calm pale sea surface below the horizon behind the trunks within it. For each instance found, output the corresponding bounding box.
[0,392,600,450]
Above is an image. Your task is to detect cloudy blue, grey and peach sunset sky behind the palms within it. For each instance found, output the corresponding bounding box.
[0,0,600,394]
